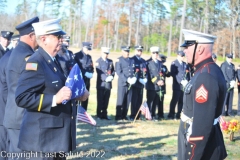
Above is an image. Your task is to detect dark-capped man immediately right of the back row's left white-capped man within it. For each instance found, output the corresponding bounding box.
[115,46,137,121]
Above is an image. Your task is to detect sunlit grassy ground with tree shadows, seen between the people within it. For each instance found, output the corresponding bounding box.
[68,49,240,160]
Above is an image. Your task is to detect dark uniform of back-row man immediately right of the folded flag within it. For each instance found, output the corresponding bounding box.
[74,51,94,110]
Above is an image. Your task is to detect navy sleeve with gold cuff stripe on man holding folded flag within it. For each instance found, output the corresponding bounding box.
[15,61,54,112]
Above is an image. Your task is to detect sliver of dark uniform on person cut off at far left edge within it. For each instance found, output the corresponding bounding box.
[0,51,11,160]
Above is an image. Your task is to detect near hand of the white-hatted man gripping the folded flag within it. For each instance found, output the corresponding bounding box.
[56,86,72,104]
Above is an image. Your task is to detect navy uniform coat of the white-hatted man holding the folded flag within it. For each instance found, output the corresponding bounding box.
[15,47,76,159]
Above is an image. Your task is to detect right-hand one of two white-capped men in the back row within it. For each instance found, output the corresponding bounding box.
[146,47,164,120]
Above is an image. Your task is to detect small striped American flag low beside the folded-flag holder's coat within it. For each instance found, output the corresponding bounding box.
[77,105,97,126]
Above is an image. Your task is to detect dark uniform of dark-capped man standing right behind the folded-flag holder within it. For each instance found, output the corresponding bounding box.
[3,41,34,153]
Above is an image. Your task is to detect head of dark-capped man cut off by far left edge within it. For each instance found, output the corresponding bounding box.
[0,31,13,58]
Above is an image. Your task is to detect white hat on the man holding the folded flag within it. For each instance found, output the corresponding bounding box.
[32,18,66,36]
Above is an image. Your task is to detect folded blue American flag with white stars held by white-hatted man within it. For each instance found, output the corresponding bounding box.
[62,64,86,104]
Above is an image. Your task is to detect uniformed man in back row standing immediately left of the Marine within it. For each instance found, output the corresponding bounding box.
[168,51,190,119]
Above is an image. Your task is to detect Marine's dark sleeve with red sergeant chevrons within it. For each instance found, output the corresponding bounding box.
[185,73,220,160]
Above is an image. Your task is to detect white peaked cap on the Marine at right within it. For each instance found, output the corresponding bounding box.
[181,29,217,47]
